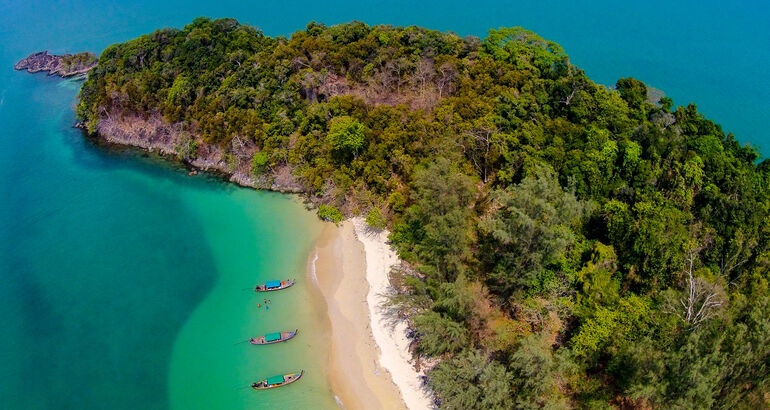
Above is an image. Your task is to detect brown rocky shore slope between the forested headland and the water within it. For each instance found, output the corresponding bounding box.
[96,115,305,193]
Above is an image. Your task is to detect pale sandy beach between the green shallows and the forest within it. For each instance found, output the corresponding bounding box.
[311,218,433,409]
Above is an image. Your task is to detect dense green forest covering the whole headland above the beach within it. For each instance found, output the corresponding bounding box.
[77,18,770,409]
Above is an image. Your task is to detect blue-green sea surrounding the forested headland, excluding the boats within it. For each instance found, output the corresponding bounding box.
[0,0,770,409]
